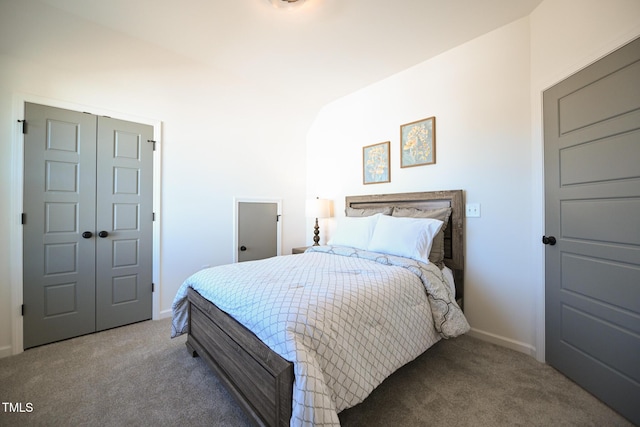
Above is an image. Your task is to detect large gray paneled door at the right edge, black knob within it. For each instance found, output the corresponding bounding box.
[543,36,640,425]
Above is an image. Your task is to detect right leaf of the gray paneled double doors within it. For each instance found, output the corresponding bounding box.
[96,117,153,331]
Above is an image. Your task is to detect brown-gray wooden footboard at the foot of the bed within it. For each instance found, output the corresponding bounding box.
[186,289,294,426]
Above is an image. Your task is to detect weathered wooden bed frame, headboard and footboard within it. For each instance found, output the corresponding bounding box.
[186,190,464,426]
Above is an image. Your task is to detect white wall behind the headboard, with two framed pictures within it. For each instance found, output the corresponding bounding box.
[307,19,535,351]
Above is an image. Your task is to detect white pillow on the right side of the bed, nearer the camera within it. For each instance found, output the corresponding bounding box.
[367,215,444,263]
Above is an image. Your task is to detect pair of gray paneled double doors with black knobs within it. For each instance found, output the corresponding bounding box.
[23,103,153,348]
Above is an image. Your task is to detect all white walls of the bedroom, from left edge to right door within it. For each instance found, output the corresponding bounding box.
[0,0,640,359]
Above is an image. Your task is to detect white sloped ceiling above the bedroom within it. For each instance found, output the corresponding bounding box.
[0,0,542,114]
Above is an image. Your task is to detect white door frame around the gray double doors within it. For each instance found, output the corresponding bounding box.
[9,93,162,355]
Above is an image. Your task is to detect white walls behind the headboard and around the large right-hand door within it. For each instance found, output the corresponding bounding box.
[307,0,640,360]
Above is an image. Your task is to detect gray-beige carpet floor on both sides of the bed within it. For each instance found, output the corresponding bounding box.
[0,319,631,427]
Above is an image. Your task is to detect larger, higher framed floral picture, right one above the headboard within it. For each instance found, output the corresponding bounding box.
[400,117,436,168]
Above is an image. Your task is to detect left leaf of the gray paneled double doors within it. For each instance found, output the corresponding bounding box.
[23,104,96,348]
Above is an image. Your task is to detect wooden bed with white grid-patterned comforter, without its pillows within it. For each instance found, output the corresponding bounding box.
[172,190,469,426]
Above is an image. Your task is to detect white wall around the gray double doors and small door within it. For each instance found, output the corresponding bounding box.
[0,2,312,357]
